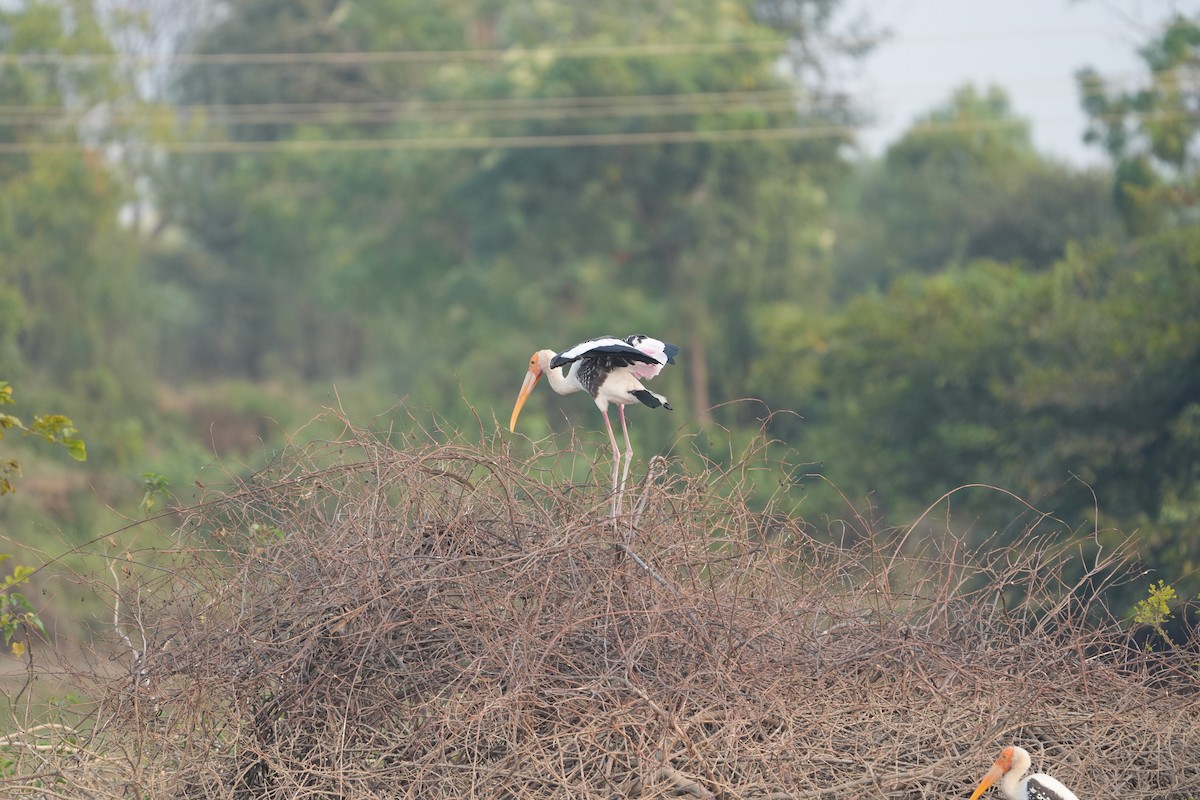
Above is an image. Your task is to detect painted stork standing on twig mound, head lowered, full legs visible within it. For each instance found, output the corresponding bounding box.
[509,333,679,517]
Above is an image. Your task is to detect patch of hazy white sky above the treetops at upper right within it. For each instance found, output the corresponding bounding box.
[851,0,1200,164]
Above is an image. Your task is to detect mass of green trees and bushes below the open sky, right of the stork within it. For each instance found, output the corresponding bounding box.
[754,20,1200,604]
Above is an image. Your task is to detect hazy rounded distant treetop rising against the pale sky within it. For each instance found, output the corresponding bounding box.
[836,85,1117,294]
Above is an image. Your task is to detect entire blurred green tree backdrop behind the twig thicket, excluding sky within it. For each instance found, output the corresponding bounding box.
[0,0,1200,623]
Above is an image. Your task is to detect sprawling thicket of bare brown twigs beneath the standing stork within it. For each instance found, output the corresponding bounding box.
[0,417,1200,800]
